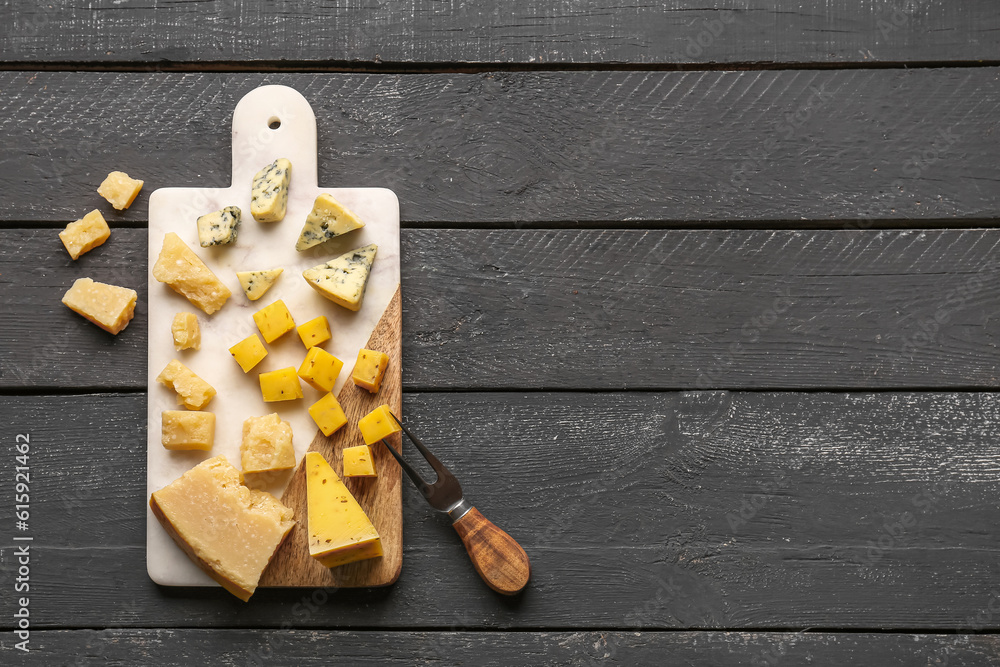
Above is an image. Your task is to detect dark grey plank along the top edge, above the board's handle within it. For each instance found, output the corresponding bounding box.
[0,0,1000,67]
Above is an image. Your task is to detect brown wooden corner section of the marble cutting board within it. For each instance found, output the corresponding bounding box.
[260,287,403,588]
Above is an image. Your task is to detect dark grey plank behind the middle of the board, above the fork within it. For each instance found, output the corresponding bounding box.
[0,229,1000,390]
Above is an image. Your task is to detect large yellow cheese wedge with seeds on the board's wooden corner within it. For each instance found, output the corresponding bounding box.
[305,452,382,567]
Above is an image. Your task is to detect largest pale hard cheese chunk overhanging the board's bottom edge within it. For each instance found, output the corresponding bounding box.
[149,456,295,602]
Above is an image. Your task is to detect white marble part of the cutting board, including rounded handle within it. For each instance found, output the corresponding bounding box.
[146,86,399,586]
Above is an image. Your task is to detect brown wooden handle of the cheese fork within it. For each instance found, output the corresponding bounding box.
[452,507,531,595]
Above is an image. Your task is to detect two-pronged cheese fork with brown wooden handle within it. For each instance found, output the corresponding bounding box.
[382,413,531,595]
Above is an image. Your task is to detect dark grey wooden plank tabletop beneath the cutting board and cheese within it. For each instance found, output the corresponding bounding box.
[0,0,1000,666]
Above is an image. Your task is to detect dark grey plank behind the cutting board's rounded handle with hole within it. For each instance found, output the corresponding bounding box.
[0,70,1000,227]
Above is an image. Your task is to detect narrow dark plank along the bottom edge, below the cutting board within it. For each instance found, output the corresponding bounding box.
[0,629,1000,667]
